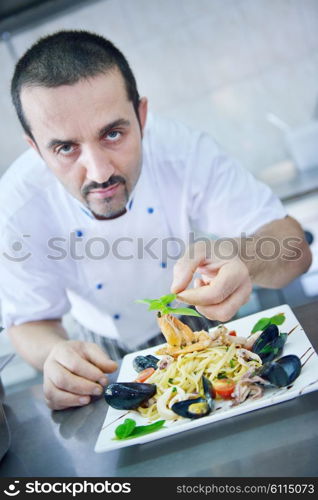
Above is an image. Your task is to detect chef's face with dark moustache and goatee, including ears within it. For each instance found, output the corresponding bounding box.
[21,69,147,218]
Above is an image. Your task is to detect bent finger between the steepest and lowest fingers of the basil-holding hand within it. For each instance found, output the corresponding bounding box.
[178,260,249,307]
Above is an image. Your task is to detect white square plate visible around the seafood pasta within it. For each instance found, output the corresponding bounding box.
[95,305,318,453]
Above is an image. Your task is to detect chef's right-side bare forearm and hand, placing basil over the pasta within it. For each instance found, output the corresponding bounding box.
[171,216,312,321]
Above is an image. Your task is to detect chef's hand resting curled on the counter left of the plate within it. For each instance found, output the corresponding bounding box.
[43,340,117,410]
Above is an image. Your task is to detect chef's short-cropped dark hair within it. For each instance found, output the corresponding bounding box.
[11,31,139,137]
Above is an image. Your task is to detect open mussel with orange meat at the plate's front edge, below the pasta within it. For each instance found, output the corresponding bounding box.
[171,376,214,418]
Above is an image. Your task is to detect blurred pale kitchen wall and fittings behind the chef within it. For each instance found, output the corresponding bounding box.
[0,0,318,391]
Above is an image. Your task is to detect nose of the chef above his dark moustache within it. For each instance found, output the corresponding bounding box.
[82,147,115,184]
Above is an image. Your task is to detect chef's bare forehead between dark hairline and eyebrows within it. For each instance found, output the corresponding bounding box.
[21,69,133,137]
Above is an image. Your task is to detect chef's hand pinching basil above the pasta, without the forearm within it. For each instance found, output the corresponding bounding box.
[171,241,252,322]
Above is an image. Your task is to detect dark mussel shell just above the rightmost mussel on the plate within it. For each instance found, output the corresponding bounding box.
[252,325,287,363]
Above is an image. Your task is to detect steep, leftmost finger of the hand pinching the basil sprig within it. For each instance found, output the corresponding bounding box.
[171,241,211,293]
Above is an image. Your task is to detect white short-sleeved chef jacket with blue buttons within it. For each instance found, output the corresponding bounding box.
[0,114,286,349]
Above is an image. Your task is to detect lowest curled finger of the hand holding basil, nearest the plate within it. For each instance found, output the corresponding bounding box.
[196,280,252,323]
